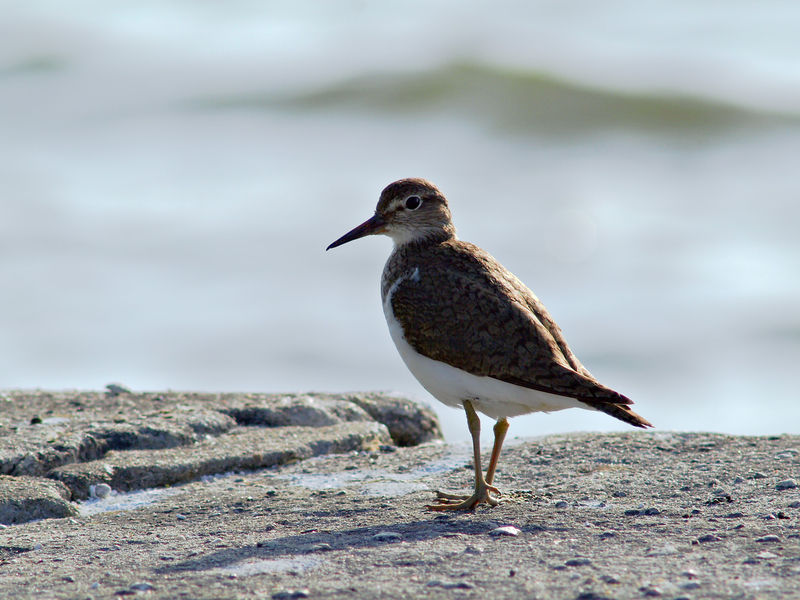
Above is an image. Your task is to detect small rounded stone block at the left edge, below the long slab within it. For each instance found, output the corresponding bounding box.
[0,475,78,525]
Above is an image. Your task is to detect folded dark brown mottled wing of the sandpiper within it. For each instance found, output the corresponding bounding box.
[390,242,632,408]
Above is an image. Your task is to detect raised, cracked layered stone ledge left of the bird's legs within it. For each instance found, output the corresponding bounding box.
[0,385,441,521]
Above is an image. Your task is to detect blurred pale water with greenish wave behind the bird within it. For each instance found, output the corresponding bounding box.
[0,0,800,440]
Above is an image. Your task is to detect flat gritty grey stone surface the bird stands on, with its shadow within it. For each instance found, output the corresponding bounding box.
[0,432,800,600]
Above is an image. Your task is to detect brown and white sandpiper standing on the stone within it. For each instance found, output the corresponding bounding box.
[327,179,652,510]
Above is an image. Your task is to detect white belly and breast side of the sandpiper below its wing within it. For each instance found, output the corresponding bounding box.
[383,275,592,419]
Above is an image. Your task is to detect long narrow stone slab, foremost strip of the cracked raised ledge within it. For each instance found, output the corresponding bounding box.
[48,421,391,500]
